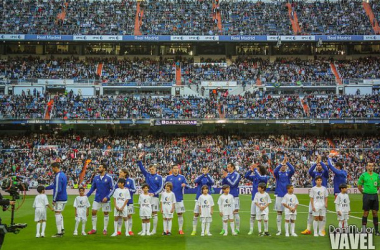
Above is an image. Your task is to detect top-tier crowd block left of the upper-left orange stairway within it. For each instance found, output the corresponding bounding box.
[0,0,136,35]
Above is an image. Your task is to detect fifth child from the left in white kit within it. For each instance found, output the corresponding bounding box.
[161,182,176,235]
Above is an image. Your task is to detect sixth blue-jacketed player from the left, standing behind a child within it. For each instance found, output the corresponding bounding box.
[191,166,215,236]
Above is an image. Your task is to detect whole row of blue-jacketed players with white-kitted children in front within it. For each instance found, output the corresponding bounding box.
[34,154,374,237]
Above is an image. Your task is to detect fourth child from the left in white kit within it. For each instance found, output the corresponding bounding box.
[138,183,152,236]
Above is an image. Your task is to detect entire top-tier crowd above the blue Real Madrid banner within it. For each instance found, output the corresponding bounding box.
[0,0,376,35]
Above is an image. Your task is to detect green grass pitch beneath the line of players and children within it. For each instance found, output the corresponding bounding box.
[1,194,380,250]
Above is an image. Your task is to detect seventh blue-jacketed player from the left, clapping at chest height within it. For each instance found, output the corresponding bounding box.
[222,163,241,233]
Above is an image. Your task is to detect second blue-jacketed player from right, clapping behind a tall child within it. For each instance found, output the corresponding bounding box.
[301,155,329,235]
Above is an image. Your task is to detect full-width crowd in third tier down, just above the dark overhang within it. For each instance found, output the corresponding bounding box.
[0,93,380,120]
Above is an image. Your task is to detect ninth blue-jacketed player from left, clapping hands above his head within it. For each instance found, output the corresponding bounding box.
[273,155,295,235]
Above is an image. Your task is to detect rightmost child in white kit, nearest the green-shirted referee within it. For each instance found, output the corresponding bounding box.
[334,184,351,228]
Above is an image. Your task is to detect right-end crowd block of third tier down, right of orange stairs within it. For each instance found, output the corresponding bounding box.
[305,95,380,119]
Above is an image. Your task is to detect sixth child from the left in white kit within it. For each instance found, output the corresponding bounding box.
[197,185,214,236]
